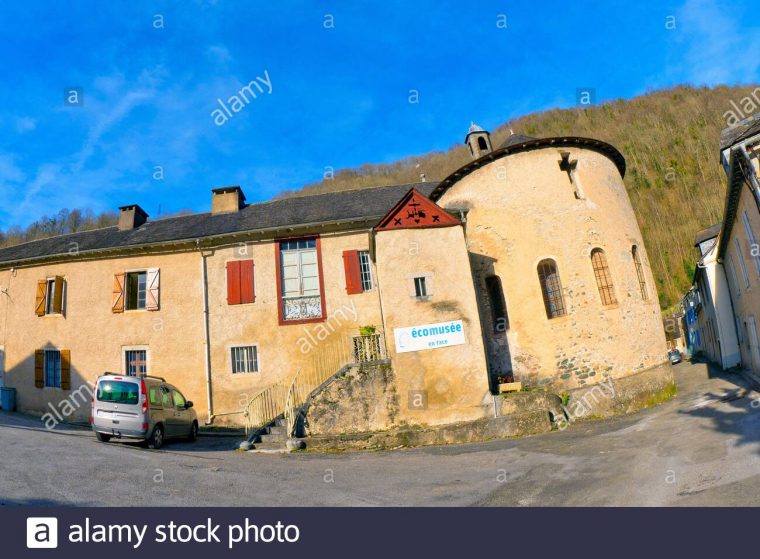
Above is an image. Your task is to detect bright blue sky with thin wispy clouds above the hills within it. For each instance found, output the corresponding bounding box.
[0,0,760,227]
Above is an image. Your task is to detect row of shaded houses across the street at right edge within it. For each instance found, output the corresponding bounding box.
[683,115,760,374]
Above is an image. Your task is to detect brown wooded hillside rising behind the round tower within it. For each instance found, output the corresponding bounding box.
[282,86,756,309]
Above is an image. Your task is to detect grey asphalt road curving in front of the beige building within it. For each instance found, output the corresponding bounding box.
[0,363,760,506]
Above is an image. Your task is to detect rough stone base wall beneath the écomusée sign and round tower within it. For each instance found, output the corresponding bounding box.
[304,362,675,451]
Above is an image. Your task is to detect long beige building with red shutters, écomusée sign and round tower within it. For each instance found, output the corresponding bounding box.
[0,125,672,440]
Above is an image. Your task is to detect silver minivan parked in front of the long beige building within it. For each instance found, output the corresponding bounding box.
[90,373,198,449]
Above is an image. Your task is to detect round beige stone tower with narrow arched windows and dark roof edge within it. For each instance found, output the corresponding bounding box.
[431,129,672,407]
